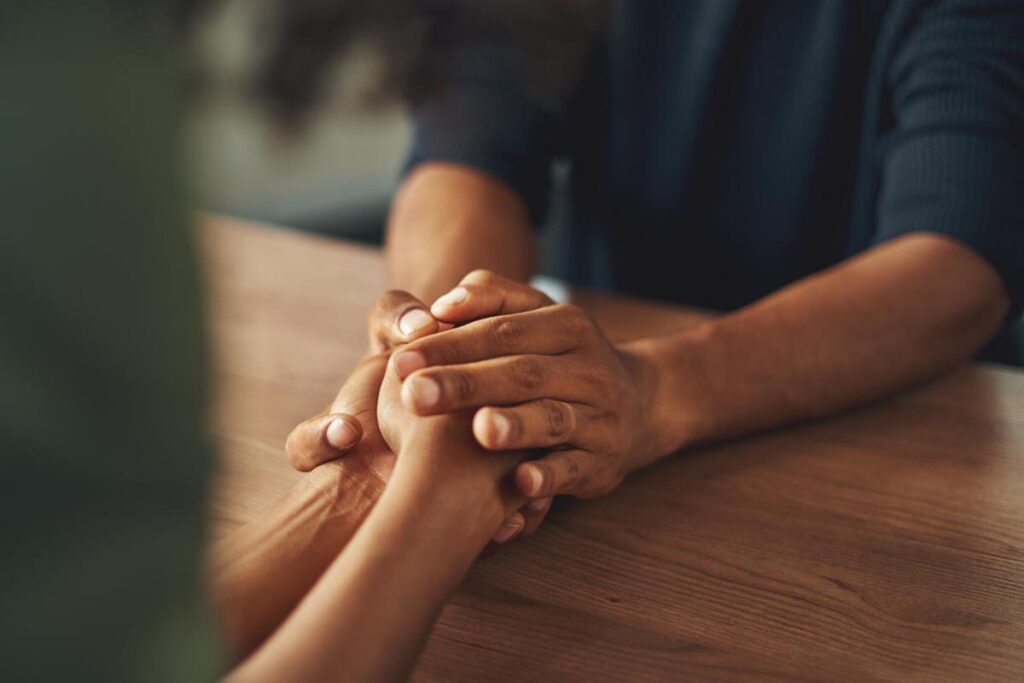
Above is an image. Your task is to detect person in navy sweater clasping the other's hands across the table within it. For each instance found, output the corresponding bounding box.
[286,0,1024,540]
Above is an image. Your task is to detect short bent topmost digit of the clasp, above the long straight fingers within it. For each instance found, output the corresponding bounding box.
[430,270,554,323]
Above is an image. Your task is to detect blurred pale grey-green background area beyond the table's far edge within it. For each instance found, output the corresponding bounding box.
[187,0,410,242]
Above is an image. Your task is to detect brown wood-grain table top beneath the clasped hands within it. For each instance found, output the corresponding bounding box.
[197,219,1024,681]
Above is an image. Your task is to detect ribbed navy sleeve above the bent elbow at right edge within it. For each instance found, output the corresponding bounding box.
[876,0,1024,310]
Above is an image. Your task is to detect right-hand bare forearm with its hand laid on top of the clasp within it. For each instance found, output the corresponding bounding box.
[392,234,1006,498]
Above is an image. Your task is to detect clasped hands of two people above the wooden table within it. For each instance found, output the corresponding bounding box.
[287,270,664,543]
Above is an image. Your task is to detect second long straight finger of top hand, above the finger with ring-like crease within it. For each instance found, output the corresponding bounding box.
[401,355,591,415]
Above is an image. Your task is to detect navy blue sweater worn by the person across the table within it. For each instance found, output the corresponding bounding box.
[410,0,1024,362]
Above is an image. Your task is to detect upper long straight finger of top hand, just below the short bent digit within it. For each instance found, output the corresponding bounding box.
[395,304,592,378]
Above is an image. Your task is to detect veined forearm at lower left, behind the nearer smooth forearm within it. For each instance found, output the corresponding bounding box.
[211,458,384,658]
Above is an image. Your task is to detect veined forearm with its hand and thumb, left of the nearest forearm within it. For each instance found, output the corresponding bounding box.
[210,355,394,659]
